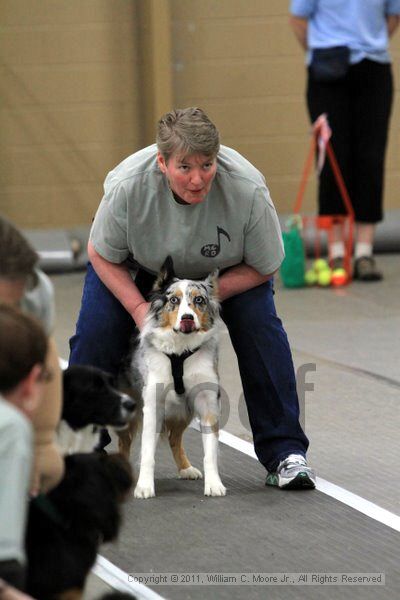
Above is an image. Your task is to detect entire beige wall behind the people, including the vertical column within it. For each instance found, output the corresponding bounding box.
[0,0,400,228]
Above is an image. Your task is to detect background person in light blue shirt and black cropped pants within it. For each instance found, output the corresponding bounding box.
[290,0,400,281]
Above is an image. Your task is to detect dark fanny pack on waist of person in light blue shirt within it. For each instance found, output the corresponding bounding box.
[310,46,350,83]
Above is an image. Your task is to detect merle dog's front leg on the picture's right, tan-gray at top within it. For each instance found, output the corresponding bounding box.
[196,392,226,496]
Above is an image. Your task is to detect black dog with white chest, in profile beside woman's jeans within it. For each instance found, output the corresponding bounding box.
[57,365,136,454]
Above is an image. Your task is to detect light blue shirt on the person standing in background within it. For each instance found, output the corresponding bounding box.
[291,0,400,64]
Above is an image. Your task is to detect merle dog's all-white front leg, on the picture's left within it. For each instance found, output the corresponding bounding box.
[134,385,160,498]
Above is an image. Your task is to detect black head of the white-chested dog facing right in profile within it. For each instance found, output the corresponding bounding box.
[62,365,136,430]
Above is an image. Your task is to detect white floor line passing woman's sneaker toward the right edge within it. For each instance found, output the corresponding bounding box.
[217,427,400,532]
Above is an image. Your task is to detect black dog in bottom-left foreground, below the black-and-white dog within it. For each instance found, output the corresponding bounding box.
[25,453,133,600]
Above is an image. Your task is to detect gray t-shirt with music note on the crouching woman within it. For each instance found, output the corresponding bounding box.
[90,144,284,278]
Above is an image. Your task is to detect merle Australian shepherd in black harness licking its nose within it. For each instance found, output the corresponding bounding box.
[119,257,226,498]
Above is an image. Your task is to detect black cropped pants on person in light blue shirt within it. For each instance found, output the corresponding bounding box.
[307,59,393,223]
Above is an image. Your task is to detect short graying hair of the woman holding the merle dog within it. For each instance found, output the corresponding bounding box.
[156,107,219,162]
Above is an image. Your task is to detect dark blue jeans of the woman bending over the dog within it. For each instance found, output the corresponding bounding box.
[69,264,308,471]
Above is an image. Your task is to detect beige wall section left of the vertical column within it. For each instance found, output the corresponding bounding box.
[0,0,141,228]
